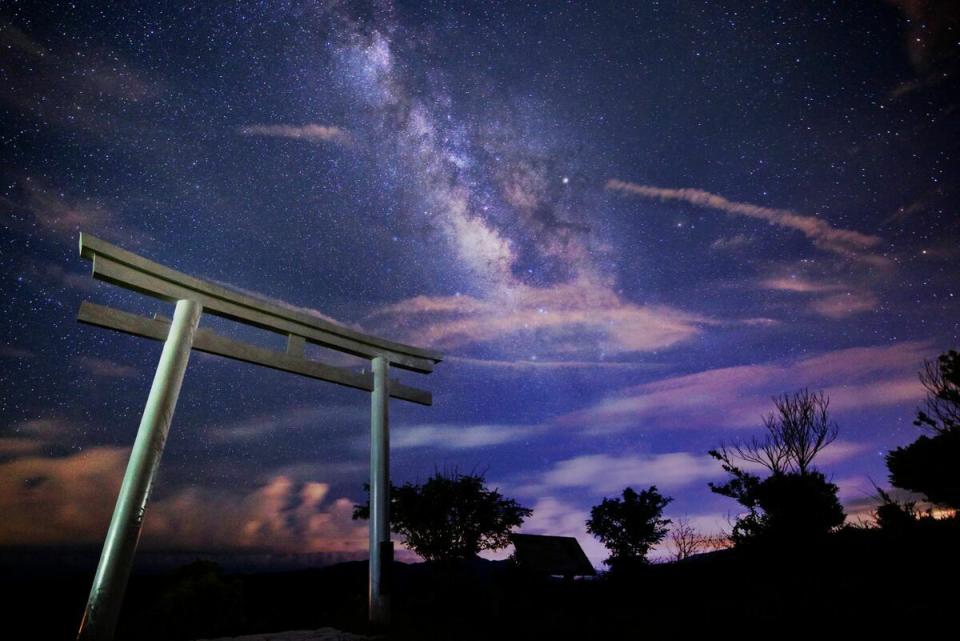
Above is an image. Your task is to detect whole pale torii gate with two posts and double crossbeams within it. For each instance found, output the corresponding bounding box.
[71,233,443,641]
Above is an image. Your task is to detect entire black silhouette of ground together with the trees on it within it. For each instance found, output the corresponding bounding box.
[0,351,960,641]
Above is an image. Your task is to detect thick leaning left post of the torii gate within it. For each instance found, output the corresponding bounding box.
[77,300,203,641]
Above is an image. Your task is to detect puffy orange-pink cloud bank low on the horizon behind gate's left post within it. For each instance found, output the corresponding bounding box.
[0,439,367,555]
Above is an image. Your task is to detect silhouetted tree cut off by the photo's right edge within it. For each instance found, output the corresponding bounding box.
[886,350,960,509]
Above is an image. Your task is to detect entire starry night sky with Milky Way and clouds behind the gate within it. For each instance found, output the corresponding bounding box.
[0,0,960,563]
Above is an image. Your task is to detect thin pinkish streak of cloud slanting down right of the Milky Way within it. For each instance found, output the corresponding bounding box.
[607,179,888,266]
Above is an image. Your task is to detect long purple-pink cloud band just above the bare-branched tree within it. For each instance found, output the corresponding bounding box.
[558,342,931,431]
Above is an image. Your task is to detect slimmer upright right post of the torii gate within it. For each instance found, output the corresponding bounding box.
[369,356,393,627]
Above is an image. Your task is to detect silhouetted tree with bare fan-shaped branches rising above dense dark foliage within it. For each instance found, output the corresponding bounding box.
[709,389,844,545]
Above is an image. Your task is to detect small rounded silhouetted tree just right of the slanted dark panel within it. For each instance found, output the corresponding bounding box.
[587,485,673,568]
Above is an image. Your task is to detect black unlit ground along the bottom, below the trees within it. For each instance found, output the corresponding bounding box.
[0,521,960,641]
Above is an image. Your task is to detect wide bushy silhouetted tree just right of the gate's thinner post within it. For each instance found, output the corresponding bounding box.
[353,471,533,561]
